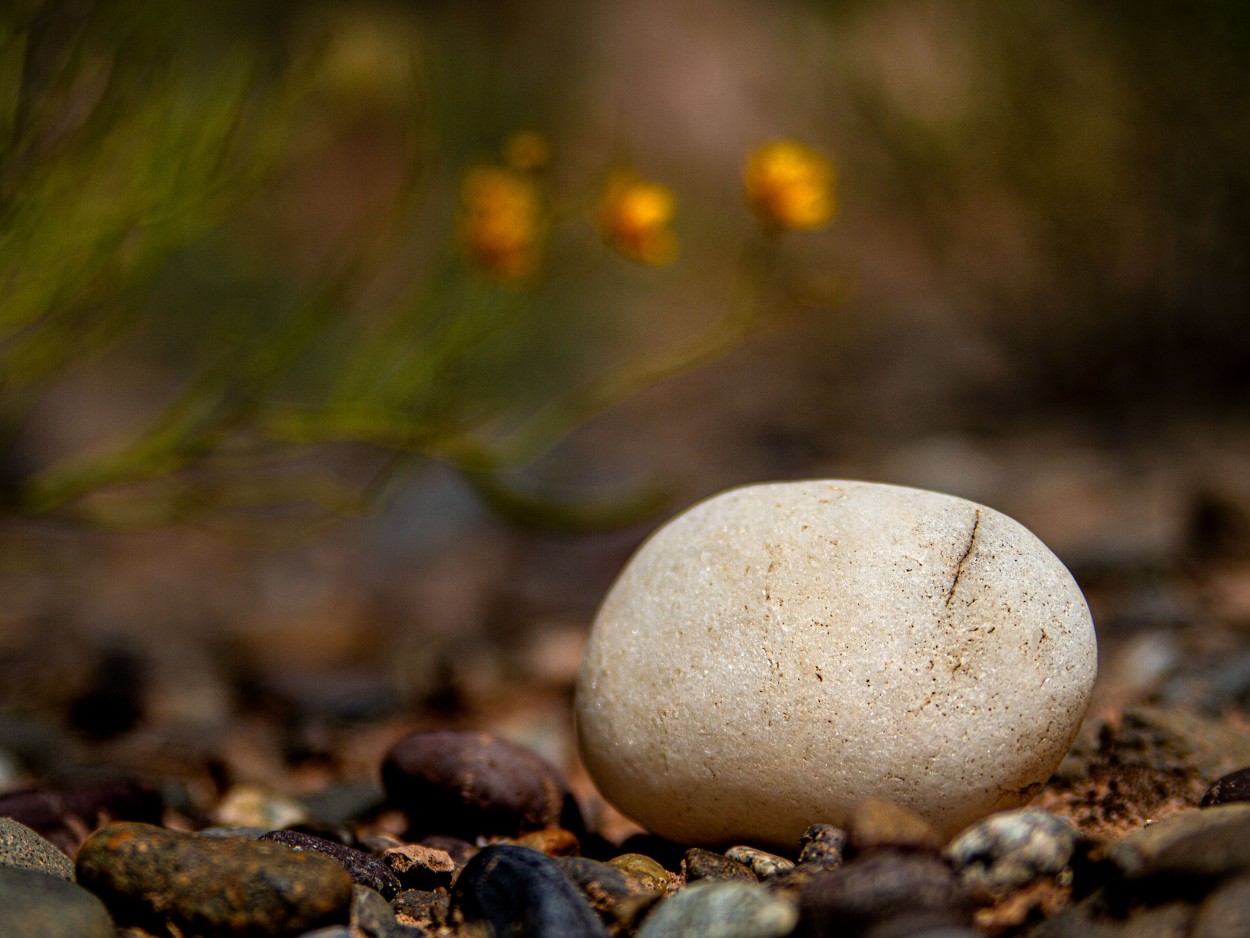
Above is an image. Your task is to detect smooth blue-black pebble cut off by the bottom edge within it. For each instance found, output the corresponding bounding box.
[451,844,608,938]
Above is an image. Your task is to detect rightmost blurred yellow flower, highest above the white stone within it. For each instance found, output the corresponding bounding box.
[743,140,838,230]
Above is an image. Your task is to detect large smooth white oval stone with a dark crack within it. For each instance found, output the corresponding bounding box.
[576,480,1098,849]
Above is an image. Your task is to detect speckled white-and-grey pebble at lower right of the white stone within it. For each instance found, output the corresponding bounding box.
[946,808,1079,894]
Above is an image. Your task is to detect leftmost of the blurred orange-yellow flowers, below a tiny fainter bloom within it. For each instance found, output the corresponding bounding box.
[460,166,543,280]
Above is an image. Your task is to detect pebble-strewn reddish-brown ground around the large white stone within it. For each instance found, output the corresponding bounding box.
[0,415,1250,938]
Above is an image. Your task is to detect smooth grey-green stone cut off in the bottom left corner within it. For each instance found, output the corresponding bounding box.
[0,867,115,938]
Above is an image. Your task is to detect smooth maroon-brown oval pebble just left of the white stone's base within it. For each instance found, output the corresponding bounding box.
[383,730,584,839]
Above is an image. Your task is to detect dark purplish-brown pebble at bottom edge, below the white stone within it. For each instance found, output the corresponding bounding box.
[796,850,973,938]
